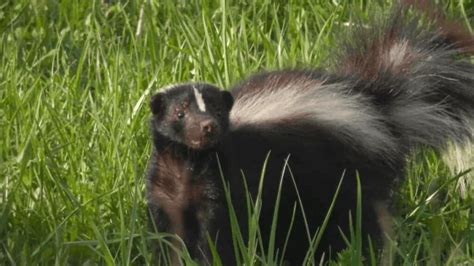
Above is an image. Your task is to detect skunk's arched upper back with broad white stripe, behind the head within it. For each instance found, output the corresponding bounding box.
[230,70,397,159]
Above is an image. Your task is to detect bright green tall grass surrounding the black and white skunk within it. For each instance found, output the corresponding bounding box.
[0,0,474,265]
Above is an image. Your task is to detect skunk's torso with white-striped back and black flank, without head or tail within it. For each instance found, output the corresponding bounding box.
[222,70,404,265]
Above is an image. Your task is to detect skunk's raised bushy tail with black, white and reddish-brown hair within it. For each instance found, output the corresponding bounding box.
[336,1,474,152]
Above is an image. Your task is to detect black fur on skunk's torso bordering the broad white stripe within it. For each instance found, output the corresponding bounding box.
[221,70,404,265]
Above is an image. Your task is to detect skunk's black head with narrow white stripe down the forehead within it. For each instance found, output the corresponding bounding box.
[150,83,234,150]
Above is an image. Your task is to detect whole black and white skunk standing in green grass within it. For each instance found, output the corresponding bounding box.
[147,1,474,265]
